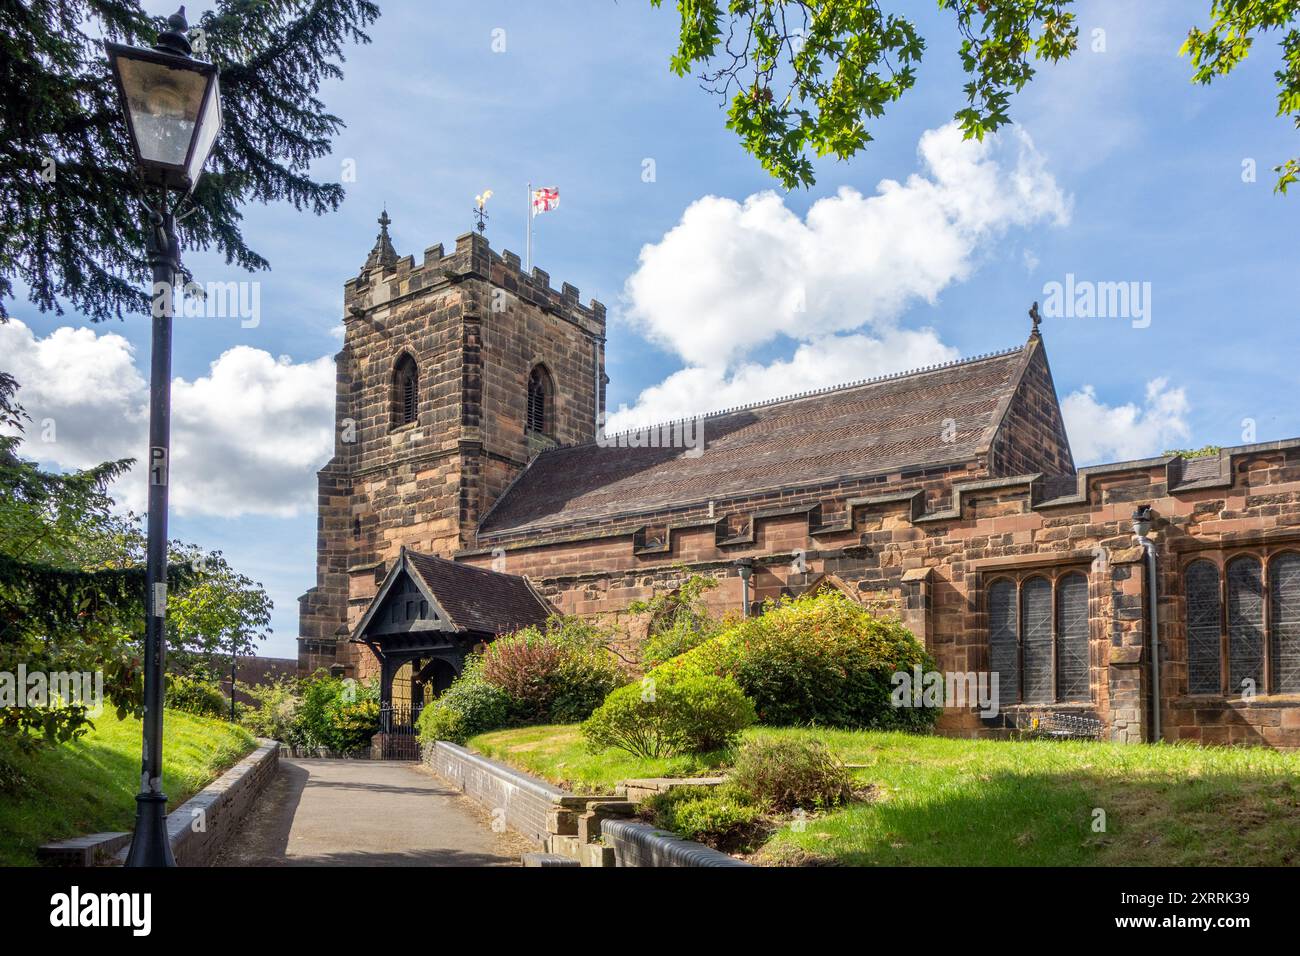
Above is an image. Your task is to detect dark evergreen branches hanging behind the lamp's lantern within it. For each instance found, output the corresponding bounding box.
[0,0,378,321]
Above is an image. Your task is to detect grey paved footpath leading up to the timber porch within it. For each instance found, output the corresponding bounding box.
[215,758,529,866]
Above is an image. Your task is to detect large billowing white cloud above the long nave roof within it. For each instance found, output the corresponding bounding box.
[611,124,1070,428]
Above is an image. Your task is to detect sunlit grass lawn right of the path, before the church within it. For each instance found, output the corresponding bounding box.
[469,726,1300,866]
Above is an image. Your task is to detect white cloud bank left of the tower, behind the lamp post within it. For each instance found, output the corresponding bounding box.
[0,320,334,516]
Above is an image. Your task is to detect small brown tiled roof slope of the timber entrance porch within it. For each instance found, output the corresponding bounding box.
[406,550,550,635]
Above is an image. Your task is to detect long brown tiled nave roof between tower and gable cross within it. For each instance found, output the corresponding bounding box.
[480,345,1030,537]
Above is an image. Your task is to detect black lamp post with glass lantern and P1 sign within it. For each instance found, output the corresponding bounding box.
[104,7,221,866]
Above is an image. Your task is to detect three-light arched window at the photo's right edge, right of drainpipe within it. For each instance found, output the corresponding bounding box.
[1183,551,1300,695]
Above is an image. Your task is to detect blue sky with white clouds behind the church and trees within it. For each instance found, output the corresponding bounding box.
[0,0,1300,656]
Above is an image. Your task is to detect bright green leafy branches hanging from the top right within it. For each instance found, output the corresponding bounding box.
[660,0,1300,193]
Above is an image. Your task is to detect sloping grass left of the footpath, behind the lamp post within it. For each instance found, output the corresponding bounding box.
[0,708,254,866]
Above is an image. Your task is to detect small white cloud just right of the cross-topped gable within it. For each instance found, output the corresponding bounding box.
[1061,378,1191,464]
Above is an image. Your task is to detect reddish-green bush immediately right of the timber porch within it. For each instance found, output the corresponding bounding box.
[481,615,625,723]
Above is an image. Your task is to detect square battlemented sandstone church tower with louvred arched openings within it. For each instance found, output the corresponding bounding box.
[298,212,606,676]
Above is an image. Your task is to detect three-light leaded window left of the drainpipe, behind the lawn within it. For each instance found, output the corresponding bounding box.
[987,571,1092,708]
